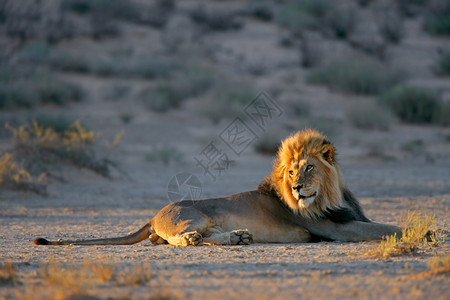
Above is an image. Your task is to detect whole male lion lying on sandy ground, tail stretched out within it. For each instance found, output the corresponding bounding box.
[34,130,401,246]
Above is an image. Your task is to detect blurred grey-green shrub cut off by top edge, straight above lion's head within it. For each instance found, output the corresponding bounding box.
[275,0,332,36]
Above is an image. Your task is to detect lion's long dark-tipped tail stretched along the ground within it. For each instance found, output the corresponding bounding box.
[33,222,151,246]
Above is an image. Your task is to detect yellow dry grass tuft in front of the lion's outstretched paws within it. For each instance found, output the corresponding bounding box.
[369,212,444,258]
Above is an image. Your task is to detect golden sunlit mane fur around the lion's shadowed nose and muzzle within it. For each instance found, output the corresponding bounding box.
[259,129,345,219]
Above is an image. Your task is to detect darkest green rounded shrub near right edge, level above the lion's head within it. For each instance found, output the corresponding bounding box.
[380,86,444,123]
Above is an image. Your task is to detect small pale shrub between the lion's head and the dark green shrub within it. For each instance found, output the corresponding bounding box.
[346,102,394,130]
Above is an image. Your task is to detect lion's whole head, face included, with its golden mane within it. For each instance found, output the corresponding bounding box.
[271,130,343,218]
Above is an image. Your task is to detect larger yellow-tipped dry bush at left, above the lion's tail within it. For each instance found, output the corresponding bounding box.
[7,121,116,177]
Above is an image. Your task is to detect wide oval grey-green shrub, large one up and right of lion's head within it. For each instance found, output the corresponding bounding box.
[309,55,402,95]
